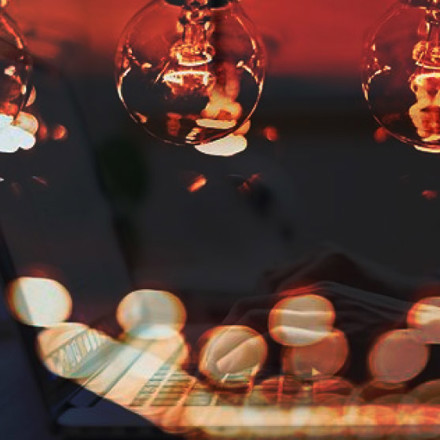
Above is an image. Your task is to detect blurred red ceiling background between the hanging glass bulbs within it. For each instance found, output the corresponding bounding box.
[8,0,394,77]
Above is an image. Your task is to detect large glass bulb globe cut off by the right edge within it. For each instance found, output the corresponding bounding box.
[363,0,440,153]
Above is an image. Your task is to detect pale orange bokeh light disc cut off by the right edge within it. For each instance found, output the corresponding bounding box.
[407,297,440,344]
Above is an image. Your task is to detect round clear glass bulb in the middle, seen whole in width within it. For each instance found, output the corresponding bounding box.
[116,0,265,145]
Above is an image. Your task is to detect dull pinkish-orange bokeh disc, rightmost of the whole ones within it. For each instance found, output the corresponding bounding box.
[369,330,429,383]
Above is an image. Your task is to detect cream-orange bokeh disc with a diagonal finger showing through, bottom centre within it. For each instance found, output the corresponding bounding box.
[199,326,267,388]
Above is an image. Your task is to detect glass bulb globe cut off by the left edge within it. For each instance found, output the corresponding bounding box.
[0,9,32,129]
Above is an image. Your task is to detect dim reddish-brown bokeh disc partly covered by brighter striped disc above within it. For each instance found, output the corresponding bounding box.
[282,330,348,380]
